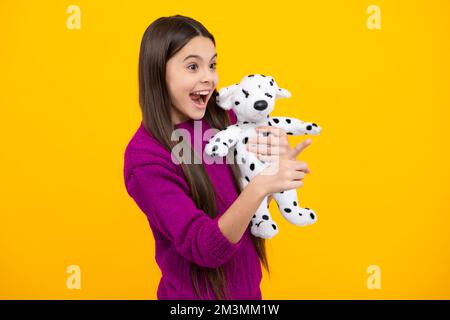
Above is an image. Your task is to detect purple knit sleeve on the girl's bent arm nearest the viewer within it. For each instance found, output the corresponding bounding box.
[127,164,242,268]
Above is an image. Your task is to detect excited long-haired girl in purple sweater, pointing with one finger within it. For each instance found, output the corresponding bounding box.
[124,15,311,299]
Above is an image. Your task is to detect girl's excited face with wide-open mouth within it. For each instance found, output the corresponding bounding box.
[166,36,219,124]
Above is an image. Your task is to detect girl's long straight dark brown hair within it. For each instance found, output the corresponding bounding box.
[139,15,269,299]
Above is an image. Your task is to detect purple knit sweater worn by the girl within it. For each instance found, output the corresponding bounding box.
[124,111,262,300]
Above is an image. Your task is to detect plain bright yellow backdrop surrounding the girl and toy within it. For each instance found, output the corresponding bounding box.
[0,0,450,299]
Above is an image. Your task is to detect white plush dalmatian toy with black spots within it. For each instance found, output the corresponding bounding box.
[205,74,321,239]
